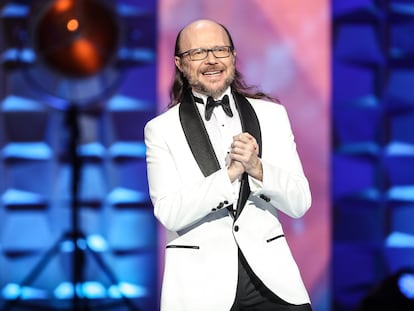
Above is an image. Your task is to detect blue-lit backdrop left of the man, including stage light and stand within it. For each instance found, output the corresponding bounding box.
[0,0,158,311]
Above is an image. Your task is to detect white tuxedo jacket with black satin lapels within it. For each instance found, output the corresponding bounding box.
[144,90,311,311]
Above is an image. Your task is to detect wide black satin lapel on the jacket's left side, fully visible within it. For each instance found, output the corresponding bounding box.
[179,92,220,177]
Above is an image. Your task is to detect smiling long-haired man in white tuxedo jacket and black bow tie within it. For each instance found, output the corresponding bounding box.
[145,20,311,311]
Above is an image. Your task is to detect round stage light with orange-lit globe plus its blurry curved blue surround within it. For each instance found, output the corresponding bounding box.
[12,0,126,105]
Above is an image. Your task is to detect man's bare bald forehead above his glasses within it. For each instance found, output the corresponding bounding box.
[180,23,230,51]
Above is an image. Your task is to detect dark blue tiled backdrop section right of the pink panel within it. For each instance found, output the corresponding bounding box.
[331,0,414,311]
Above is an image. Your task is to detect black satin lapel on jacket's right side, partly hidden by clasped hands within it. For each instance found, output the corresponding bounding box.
[233,93,262,219]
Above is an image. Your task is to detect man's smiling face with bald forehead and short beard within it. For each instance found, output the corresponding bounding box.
[175,22,236,98]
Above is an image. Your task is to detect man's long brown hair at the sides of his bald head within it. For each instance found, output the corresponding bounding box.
[168,24,276,108]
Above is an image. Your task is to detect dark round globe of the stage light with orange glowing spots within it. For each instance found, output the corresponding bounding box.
[32,0,119,78]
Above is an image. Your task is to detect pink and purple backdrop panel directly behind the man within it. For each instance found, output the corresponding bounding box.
[157,0,330,311]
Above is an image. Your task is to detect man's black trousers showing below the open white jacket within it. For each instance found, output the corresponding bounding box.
[230,250,312,311]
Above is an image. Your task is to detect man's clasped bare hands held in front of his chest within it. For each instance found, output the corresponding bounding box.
[227,132,263,182]
